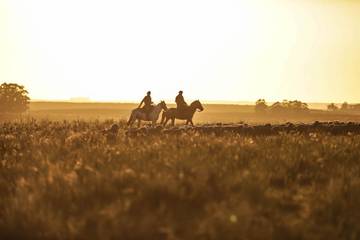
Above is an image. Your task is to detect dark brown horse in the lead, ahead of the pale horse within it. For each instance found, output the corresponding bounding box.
[161,100,204,126]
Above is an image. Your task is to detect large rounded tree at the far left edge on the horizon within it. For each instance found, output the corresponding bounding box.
[0,83,30,113]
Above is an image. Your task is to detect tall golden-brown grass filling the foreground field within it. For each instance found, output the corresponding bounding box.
[0,121,360,240]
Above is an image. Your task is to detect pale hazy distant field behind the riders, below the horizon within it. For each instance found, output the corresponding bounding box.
[24,102,360,123]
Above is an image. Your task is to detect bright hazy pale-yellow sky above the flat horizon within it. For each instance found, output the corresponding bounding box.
[0,0,360,102]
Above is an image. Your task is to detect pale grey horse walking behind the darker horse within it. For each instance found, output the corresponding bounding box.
[127,101,168,127]
